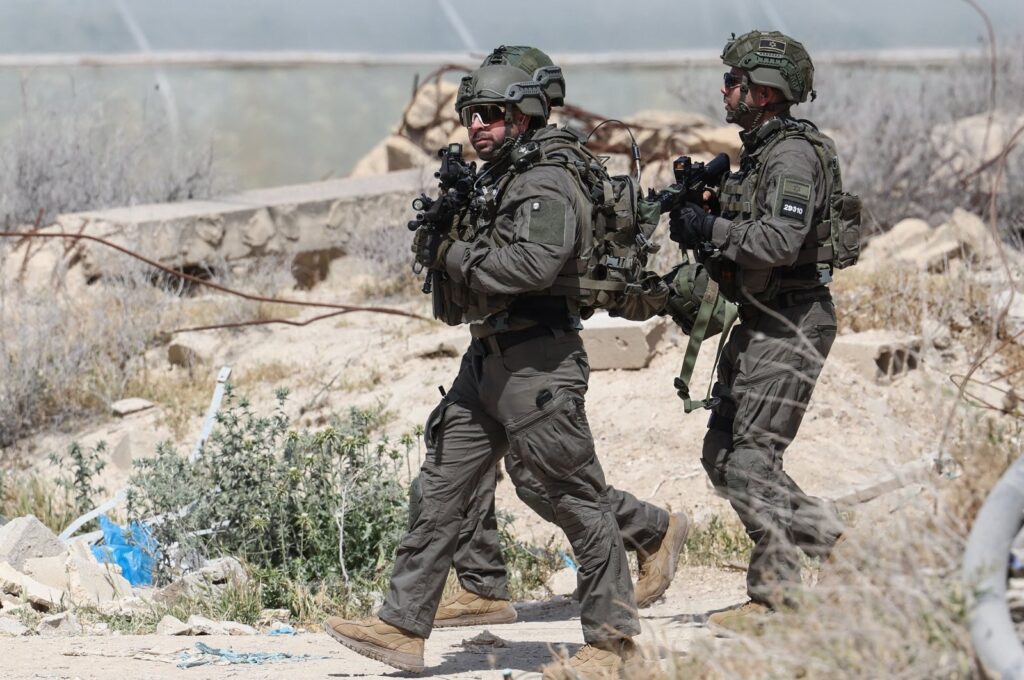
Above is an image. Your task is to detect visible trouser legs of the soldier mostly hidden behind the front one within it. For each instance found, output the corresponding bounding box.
[409,452,669,600]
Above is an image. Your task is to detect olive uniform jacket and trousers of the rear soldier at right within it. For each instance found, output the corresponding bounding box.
[702,118,842,605]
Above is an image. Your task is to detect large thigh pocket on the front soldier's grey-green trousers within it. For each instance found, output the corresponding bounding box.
[505,390,594,479]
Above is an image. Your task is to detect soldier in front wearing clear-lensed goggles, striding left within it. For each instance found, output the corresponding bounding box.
[326,48,671,678]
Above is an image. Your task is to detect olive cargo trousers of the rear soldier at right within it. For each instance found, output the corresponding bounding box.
[701,292,843,606]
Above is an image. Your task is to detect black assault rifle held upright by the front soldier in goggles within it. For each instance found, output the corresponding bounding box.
[409,143,476,293]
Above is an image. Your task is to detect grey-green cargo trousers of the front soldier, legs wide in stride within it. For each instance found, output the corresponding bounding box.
[378,332,640,643]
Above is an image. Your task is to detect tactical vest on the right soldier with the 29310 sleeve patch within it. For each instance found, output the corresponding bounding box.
[707,119,861,302]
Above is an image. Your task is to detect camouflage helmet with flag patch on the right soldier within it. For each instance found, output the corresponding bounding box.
[722,31,817,103]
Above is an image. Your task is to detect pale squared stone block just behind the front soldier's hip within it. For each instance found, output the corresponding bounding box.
[580,312,667,371]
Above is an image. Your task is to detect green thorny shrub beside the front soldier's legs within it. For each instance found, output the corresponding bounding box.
[129,390,409,582]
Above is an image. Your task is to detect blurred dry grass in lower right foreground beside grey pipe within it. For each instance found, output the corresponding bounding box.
[630,418,1020,679]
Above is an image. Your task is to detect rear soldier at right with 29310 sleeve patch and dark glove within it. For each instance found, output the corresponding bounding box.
[670,31,859,626]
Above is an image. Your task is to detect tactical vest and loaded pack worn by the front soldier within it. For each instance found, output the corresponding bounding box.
[430,129,669,325]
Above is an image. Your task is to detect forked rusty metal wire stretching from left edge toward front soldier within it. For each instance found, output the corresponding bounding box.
[0,230,426,335]
